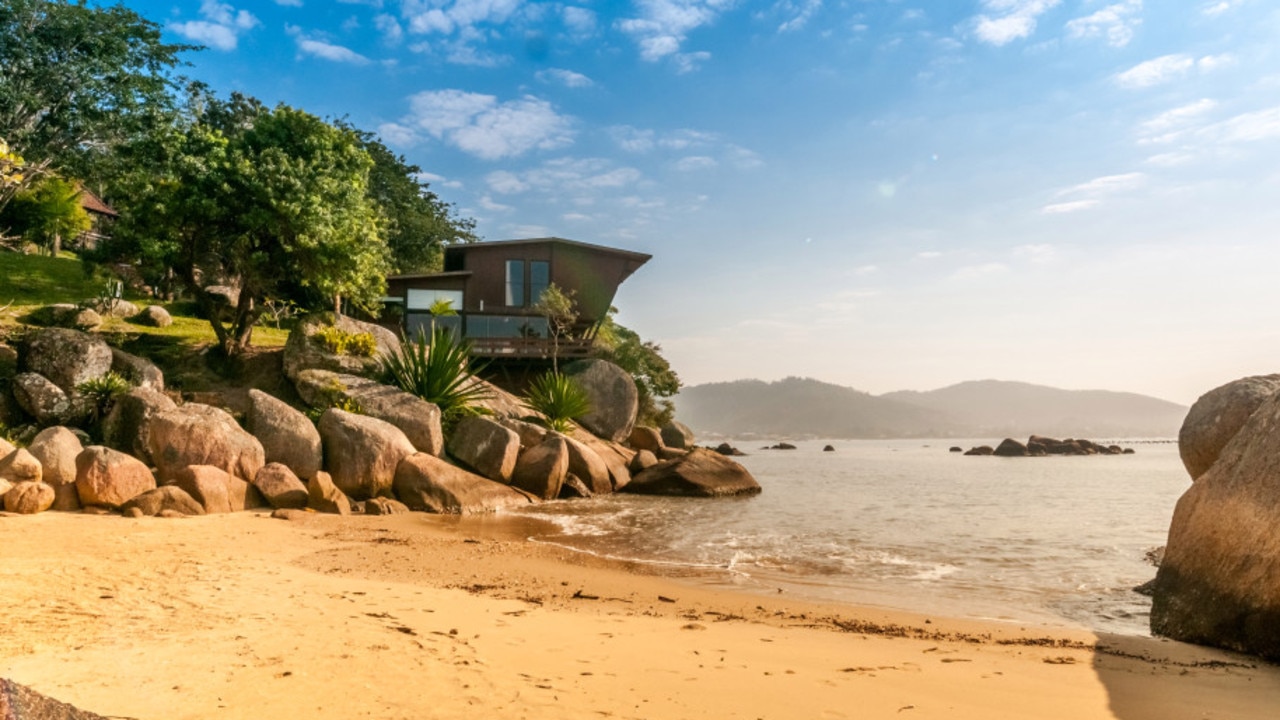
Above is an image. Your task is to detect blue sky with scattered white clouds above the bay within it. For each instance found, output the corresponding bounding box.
[125,0,1280,404]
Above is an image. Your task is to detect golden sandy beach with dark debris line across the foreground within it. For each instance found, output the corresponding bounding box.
[0,512,1280,720]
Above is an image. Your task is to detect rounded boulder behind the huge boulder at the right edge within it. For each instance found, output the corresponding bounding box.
[1178,375,1280,480]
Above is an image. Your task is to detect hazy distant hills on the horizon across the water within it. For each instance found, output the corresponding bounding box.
[676,378,1187,439]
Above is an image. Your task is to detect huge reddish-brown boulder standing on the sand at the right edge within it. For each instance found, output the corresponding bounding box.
[1151,386,1280,660]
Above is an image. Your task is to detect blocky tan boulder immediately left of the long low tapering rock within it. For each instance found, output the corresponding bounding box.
[320,407,416,500]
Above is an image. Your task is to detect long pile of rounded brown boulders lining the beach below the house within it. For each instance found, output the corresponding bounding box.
[0,318,760,516]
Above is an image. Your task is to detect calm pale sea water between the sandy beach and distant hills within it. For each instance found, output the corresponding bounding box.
[512,439,1190,634]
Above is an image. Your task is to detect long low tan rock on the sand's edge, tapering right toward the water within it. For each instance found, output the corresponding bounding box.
[394,452,532,515]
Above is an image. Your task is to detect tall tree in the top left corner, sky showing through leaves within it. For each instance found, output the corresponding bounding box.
[0,0,196,208]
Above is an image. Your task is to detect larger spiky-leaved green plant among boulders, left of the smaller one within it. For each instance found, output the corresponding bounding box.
[381,328,489,416]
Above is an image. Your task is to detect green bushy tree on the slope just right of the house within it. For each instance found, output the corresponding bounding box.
[594,307,680,427]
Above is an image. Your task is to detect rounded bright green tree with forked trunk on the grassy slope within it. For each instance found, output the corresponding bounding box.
[96,92,388,356]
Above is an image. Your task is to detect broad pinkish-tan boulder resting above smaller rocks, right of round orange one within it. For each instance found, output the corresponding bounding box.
[147,402,266,481]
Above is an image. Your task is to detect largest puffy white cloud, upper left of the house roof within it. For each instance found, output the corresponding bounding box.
[379,90,573,160]
